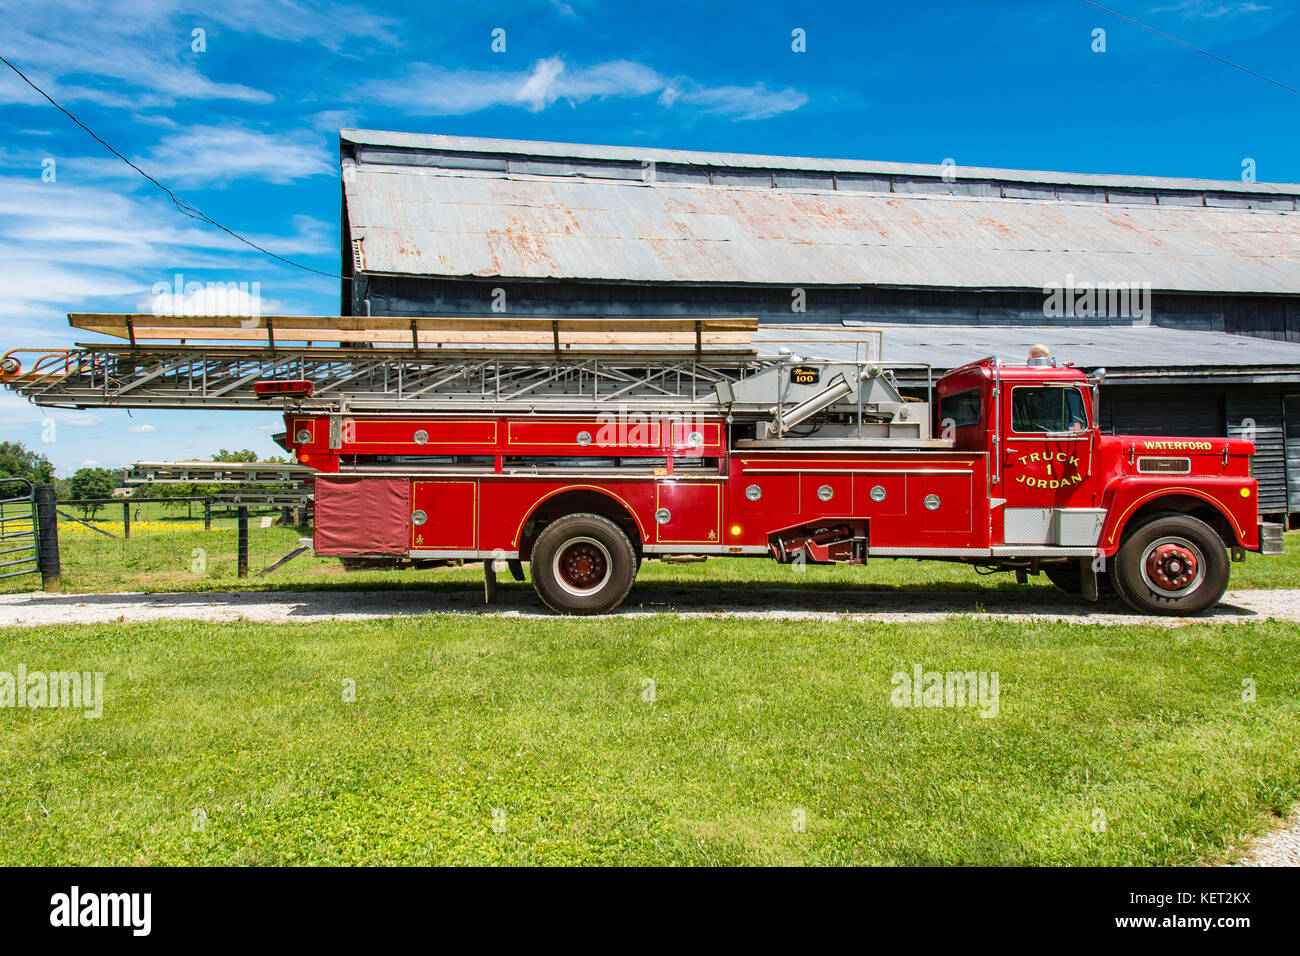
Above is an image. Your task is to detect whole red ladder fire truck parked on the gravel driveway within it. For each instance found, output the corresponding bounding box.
[3,316,1282,615]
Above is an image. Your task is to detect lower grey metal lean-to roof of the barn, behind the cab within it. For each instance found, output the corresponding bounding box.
[754,323,1300,381]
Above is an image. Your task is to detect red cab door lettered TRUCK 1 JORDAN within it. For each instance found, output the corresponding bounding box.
[1001,382,1102,548]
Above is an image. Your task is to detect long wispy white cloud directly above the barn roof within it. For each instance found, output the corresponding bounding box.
[367,57,809,120]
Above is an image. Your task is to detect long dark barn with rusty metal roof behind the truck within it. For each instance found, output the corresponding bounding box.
[339,130,1300,523]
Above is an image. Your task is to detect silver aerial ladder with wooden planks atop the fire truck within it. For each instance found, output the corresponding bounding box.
[0,313,943,447]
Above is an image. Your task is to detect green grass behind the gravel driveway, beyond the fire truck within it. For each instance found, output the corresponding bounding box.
[0,515,1300,593]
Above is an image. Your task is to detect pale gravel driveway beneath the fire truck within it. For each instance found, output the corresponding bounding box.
[0,585,1300,627]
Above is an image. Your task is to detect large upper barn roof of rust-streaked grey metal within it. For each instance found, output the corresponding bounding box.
[341,130,1300,294]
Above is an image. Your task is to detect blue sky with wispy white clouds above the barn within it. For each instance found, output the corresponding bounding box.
[0,0,1300,475]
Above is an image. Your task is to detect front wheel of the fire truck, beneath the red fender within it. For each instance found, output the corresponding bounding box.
[1110,514,1229,617]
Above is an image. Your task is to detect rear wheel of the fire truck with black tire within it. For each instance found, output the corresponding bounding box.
[529,514,637,614]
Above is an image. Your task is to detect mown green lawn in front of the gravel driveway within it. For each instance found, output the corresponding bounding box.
[0,613,1300,865]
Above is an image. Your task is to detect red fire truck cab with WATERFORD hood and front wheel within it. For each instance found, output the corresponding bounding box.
[937,347,1263,614]
